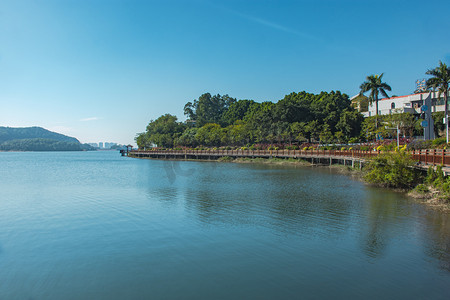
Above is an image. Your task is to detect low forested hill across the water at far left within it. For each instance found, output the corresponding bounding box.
[0,127,93,151]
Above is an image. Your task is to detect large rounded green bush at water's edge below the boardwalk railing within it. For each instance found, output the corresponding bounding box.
[364,152,421,188]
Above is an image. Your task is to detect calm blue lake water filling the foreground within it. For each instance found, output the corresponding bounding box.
[0,152,450,299]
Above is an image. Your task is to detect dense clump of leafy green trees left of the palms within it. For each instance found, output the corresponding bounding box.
[136,91,363,148]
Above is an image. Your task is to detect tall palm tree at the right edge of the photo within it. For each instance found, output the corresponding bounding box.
[425,61,450,143]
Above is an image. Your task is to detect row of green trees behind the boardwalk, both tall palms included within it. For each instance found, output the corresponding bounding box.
[135,62,450,148]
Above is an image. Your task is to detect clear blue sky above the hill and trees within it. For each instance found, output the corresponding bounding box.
[0,0,450,144]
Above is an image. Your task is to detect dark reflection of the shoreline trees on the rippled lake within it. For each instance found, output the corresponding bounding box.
[148,161,450,270]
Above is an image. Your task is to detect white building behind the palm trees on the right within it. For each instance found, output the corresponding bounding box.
[362,92,450,117]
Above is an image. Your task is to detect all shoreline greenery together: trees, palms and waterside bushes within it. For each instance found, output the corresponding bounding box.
[135,62,450,211]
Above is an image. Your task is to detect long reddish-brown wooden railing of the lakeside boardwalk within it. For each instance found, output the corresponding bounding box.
[129,149,450,166]
